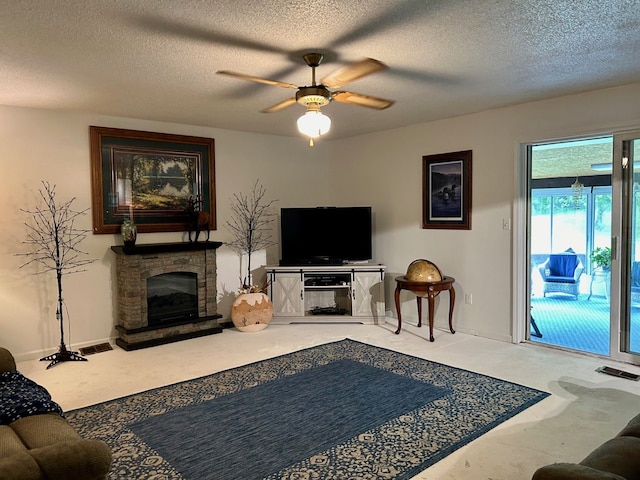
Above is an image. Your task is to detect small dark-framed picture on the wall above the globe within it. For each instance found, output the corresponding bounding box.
[422,150,472,230]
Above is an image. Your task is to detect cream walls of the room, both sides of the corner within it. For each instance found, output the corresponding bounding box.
[0,84,640,359]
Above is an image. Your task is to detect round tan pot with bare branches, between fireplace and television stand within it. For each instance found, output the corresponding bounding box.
[226,180,276,332]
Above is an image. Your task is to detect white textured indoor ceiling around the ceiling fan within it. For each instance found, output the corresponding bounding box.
[0,0,640,148]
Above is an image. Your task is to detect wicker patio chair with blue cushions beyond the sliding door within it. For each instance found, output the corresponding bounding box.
[539,253,584,300]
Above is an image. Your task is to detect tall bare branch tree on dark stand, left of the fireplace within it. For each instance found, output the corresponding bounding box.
[18,181,95,368]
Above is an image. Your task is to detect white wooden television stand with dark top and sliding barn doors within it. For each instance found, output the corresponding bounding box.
[265,263,386,324]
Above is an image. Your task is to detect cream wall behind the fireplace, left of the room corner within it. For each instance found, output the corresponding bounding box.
[0,107,329,359]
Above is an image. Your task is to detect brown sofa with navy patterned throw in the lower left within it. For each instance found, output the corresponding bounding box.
[0,347,111,480]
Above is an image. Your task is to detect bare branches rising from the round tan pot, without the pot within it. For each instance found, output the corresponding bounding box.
[226,180,277,289]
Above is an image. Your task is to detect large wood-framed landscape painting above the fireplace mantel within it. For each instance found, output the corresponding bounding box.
[89,126,216,234]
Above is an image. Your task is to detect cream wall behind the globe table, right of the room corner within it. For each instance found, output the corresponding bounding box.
[331,84,640,341]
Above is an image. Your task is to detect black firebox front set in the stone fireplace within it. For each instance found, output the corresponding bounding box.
[147,272,198,326]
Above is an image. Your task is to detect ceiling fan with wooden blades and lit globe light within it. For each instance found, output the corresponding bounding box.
[217,53,394,145]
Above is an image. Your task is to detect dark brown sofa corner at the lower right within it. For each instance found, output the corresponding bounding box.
[533,415,640,480]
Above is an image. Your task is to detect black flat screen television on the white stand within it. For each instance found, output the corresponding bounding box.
[280,207,372,266]
